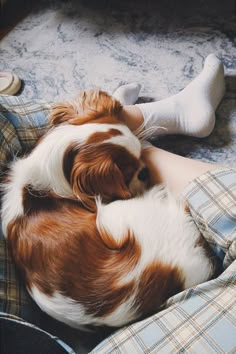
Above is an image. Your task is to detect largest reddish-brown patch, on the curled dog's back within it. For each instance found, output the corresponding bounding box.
[8,190,141,317]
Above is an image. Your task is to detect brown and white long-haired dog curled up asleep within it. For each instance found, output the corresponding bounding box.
[1,91,218,328]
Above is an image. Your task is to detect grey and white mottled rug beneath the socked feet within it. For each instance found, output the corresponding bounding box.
[0,0,236,352]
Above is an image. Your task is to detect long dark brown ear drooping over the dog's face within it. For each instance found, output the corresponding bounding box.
[64,146,131,211]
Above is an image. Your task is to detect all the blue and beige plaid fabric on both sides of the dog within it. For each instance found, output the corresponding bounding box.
[0,96,236,354]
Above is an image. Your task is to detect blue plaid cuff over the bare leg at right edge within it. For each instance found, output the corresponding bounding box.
[184,168,236,268]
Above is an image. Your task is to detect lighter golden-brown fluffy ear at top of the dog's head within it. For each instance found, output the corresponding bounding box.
[49,90,122,125]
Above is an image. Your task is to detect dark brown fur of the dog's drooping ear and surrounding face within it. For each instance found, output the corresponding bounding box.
[63,138,140,211]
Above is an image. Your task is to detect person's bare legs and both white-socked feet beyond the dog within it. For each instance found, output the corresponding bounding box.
[114,54,225,194]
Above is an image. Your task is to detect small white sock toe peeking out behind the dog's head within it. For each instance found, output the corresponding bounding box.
[112,83,141,105]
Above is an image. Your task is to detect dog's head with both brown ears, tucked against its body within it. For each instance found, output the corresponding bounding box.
[50,90,148,210]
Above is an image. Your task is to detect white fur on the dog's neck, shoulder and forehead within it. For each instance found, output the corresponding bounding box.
[2,123,141,235]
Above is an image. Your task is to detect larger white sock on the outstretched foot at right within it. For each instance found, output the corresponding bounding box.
[136,54,225,137]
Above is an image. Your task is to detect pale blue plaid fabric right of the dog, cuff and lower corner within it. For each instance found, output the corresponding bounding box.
[92,168,236,354]
